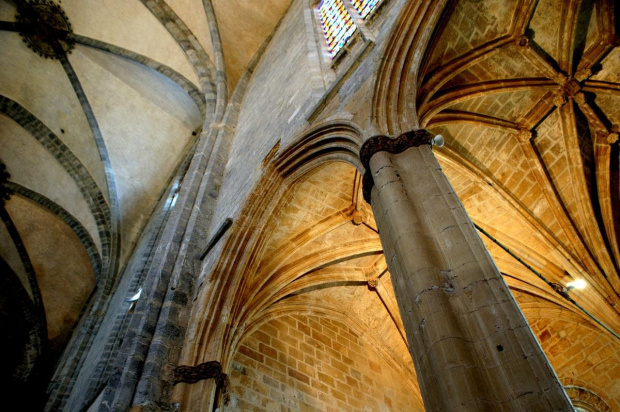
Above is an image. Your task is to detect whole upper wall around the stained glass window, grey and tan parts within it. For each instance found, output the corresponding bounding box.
[206,0,405,241]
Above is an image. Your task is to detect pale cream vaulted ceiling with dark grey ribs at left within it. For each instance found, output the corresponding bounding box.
[0,0,290,360]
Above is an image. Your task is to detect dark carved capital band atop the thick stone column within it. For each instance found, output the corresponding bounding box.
[360,129,435,203]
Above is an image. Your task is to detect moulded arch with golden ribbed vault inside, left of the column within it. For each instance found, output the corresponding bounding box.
[177,122,422,405]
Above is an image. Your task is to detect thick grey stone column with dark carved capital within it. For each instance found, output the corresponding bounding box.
[360,130,573,411]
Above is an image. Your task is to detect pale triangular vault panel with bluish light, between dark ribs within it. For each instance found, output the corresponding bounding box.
[70,48,201,257]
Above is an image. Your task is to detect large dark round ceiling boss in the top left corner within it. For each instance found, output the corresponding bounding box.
[16,0,75,59]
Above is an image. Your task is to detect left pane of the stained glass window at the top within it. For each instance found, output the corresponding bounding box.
[319,0,357,59]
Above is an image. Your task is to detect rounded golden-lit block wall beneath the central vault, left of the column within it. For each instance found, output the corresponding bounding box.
[222,314,424,411]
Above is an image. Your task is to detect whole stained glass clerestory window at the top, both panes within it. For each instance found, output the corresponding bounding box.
[318,0,383,59]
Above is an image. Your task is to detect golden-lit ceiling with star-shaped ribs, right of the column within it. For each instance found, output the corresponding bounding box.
[417,0,620,409]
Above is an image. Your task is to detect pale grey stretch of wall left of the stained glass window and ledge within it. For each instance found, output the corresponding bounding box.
[212,0,322,230]
